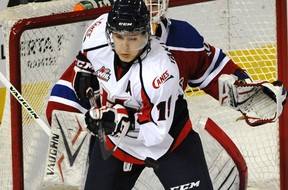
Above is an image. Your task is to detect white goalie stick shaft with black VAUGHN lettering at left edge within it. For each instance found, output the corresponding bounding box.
[0,72,50,136]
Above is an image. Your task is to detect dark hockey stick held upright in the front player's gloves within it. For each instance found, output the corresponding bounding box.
[86,88,129,160]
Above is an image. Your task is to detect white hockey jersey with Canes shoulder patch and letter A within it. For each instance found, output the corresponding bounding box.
[81,14,192,164]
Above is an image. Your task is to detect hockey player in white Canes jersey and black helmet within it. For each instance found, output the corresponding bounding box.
[51,0,213,190]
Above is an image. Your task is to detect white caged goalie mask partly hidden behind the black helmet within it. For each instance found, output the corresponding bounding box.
[145,0,169,23]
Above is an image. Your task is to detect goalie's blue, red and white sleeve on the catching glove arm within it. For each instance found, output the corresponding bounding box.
[166,20,246,99]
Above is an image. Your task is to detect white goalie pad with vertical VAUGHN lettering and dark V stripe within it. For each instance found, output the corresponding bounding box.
[43,110,91,188]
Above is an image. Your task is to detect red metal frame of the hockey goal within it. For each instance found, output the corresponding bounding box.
[0,0,288,189]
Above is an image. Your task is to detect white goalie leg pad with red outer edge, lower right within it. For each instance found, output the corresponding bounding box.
[195,117,248,190]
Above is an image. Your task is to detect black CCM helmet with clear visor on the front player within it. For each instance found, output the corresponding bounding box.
[106,0,150,50]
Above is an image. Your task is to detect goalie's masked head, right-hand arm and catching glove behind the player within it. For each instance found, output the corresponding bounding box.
[146,0,287,126]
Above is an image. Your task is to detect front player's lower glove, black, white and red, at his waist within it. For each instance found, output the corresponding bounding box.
[85,104,131,136]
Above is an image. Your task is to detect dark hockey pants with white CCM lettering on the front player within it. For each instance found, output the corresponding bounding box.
[85,130,213,190]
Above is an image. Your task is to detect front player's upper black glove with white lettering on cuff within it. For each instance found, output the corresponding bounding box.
[73,52,99,102]
